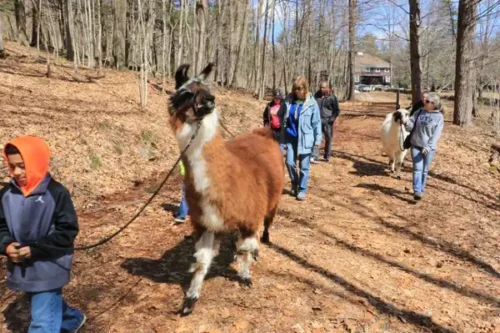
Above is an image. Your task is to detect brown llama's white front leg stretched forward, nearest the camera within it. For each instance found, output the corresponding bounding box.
[182,231,218,315]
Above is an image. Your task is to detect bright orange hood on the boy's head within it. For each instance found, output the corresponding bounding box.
[3,136,50,196]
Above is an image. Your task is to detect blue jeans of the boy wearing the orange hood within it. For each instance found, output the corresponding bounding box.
[28,289,83,333]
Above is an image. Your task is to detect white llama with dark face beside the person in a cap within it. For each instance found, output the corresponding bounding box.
[381,109,409,179]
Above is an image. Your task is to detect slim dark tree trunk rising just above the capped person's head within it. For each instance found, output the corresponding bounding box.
[409,0,422,104]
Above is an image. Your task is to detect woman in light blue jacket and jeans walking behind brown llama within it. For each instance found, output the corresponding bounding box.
[279,76,321,201]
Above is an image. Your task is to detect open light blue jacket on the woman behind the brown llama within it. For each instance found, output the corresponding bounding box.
[280,95,322,155]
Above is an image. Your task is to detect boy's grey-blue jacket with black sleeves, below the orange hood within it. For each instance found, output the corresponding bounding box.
[0,174,78,292]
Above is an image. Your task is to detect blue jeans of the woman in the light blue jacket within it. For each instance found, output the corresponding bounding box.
[286,138,311,192]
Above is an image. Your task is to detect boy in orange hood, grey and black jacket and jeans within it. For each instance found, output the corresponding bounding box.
[0,136,86,333]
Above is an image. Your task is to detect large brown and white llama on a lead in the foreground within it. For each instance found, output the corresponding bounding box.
[169,64,285,315]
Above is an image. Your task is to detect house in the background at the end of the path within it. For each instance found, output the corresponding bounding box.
[354,52,391,86]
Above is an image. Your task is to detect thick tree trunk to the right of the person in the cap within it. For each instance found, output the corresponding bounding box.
[453,0,477,127]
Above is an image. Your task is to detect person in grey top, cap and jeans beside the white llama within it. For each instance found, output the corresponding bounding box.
[404,93,444,201]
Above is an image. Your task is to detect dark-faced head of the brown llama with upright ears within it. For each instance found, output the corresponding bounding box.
[169,63,215,123]
